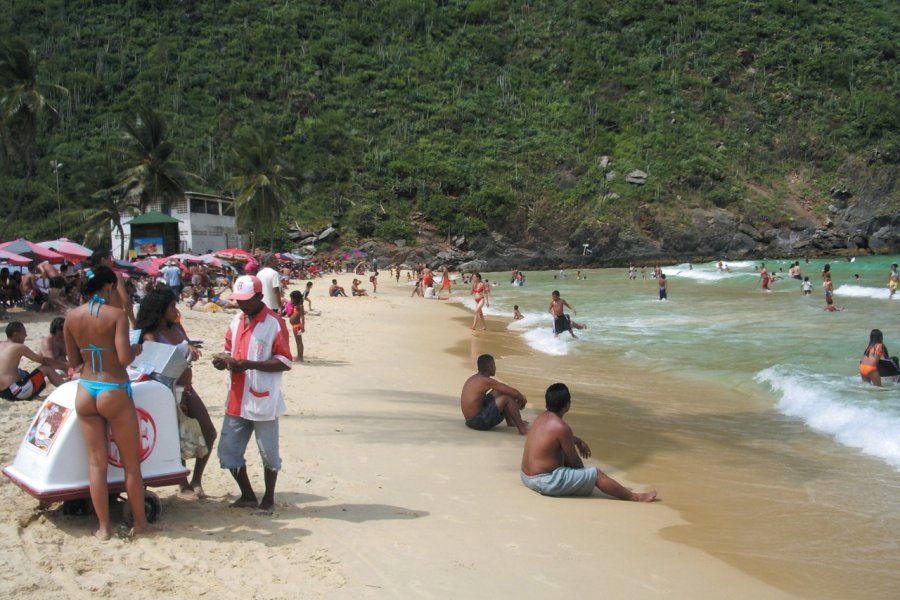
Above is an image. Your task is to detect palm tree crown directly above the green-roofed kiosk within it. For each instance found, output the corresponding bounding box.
[112,108,194,212]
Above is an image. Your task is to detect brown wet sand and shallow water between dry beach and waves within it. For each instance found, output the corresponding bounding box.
[460,274,900,599]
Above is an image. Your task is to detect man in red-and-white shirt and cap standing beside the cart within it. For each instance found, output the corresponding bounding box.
[213,275,293,512]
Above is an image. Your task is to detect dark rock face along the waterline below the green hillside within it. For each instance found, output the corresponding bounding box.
[308,172,900,271]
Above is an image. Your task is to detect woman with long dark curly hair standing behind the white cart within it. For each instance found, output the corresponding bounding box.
[135,289,216,498]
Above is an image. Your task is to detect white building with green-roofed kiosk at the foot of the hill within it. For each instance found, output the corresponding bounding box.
[112,192,241,257]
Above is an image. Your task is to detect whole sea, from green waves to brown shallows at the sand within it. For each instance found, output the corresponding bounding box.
[454,256,900,598]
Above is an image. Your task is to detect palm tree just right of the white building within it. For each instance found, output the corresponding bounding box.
[229,129,294,250]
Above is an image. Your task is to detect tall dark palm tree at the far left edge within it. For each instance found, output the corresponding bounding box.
[0,41,69,230]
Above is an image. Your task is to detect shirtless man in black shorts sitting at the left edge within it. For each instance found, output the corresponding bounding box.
[0,321,69,400]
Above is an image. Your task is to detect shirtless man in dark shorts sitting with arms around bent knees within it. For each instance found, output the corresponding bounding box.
[460,354,528,435]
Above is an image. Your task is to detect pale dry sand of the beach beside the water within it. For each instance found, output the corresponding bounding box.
[0,274,793,599]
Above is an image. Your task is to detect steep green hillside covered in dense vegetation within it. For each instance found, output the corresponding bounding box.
[0,0,900,253]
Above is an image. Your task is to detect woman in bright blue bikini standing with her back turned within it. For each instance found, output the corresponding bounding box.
[63,266,156,540]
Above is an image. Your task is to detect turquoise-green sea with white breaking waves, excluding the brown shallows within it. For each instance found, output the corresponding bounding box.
[474,256,900,471]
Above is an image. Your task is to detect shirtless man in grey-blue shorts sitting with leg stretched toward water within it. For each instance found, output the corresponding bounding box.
[520,383,656,502]
